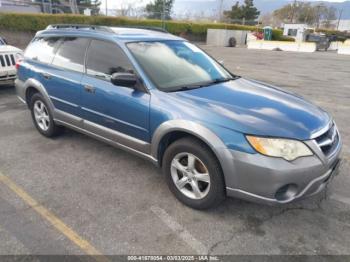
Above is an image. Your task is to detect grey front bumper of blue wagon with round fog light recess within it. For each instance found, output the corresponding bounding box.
[225,135,341,204]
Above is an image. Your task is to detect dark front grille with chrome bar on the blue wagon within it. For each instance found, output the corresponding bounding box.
[315,124,339,156]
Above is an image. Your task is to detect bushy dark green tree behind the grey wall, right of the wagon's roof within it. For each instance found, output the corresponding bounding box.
[224,0,260,21]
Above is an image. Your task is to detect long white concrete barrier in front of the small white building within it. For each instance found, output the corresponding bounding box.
[248,40,316,53]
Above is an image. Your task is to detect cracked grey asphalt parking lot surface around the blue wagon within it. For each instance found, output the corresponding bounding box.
[0,46,350,255]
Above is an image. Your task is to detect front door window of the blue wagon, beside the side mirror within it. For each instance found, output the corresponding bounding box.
[86,40,134,79]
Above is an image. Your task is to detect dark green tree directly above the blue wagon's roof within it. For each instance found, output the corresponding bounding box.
[146,0,174,20]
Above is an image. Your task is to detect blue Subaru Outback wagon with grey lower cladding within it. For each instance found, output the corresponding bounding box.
[16,25,341,209]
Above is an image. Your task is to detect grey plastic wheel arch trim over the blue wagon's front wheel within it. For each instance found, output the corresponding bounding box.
[151,120,235,186]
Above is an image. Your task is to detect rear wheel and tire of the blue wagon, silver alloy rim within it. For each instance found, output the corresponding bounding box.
[30,93,63,137]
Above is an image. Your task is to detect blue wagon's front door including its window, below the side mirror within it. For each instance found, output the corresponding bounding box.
[82,40,150,142]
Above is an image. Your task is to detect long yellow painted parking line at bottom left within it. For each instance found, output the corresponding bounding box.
[0,172,109,262]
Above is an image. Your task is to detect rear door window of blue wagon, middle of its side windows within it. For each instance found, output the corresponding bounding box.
[52,37,89,73]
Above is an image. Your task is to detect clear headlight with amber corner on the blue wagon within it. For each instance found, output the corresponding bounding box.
[246,136,313,161]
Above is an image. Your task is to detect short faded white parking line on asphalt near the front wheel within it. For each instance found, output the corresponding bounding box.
[150,206,208,255]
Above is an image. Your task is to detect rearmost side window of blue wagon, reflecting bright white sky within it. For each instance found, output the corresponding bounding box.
[24,37,60,64]
